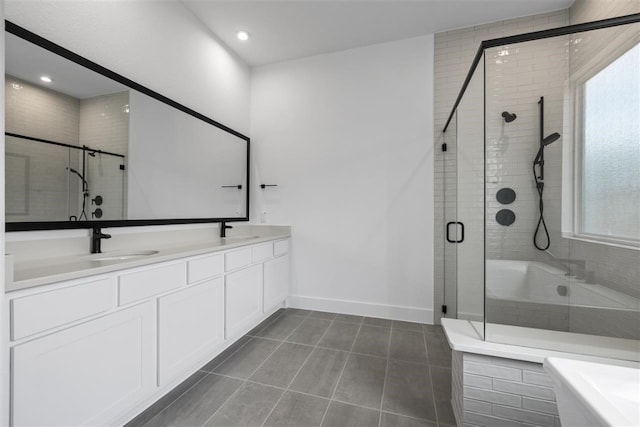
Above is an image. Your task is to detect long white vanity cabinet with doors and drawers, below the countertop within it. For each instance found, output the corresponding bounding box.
[8,239,289,426]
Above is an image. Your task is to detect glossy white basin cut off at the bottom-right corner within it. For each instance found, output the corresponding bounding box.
[544,357,640,427]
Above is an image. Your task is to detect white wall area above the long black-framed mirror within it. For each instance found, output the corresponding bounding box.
[6,0,250,133]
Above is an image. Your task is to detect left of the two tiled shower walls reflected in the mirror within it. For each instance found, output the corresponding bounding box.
[5,75,81,222]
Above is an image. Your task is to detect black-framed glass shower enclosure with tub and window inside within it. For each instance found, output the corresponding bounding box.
[436,14,640,360]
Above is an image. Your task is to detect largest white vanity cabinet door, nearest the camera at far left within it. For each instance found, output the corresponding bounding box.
[11,302,156,426]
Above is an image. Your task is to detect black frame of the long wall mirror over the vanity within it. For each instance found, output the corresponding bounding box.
[5,20,251,231]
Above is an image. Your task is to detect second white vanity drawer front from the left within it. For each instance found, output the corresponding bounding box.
[118,262,186,305]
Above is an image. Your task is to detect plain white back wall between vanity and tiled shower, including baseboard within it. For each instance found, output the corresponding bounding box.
[251,36,433,322]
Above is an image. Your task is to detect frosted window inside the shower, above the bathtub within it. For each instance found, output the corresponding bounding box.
[575,45,640,244]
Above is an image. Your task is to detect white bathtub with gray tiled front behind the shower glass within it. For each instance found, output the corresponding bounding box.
[486,260,640,339]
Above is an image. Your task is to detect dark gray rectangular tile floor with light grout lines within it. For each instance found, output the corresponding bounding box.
[127,309,455,427]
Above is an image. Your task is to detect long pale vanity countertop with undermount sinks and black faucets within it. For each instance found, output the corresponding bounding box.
[5,227,290,292]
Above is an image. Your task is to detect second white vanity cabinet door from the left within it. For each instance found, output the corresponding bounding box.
[158,278,224,385]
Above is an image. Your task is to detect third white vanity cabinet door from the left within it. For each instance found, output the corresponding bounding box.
[225,264,262,338]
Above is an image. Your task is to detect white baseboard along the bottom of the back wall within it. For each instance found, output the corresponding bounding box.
[287,295,433,324]
